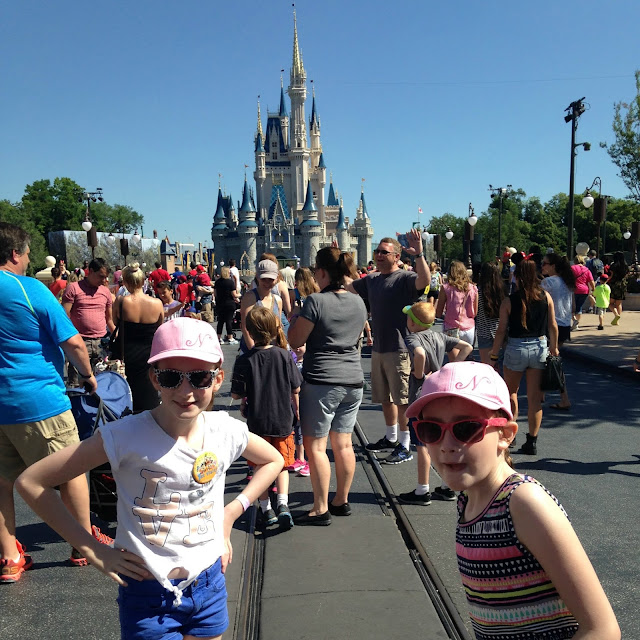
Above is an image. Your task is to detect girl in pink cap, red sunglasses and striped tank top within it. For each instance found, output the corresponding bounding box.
[407,362,620,640]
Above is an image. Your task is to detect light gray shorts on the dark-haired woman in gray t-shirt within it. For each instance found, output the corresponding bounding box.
[300,382,362,438]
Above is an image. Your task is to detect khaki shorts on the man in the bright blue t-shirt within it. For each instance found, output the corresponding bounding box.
[0,410,80,482]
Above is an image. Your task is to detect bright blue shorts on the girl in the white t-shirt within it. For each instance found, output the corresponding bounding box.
[118,558,229,640]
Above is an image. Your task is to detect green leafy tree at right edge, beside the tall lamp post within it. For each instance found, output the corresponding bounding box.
[600,70,640,203]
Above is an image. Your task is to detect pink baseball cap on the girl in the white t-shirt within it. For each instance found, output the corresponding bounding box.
[147,318,224,364]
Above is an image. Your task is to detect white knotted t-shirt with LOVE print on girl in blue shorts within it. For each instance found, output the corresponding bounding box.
[100,411,249,605]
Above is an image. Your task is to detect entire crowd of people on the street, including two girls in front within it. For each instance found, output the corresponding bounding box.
[0,218,628,639]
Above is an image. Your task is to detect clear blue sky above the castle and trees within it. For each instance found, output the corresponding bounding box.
[0,0,640,248]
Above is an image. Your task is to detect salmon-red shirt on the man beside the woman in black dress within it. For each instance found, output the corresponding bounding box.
[62,280,112,338]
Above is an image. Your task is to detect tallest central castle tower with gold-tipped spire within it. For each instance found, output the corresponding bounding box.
[287,11,310,212]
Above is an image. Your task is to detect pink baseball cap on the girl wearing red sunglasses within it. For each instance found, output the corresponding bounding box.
[407,362,513,420]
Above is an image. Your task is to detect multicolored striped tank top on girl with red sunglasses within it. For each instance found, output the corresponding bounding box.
[456,473,578,640]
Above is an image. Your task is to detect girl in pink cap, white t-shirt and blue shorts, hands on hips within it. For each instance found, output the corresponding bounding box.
[16,318,283,640]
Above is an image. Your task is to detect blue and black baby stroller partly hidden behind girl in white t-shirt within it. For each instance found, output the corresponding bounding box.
[67,371,133,522]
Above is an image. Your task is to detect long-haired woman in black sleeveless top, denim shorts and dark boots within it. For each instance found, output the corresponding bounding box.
[490,260,558,455]
